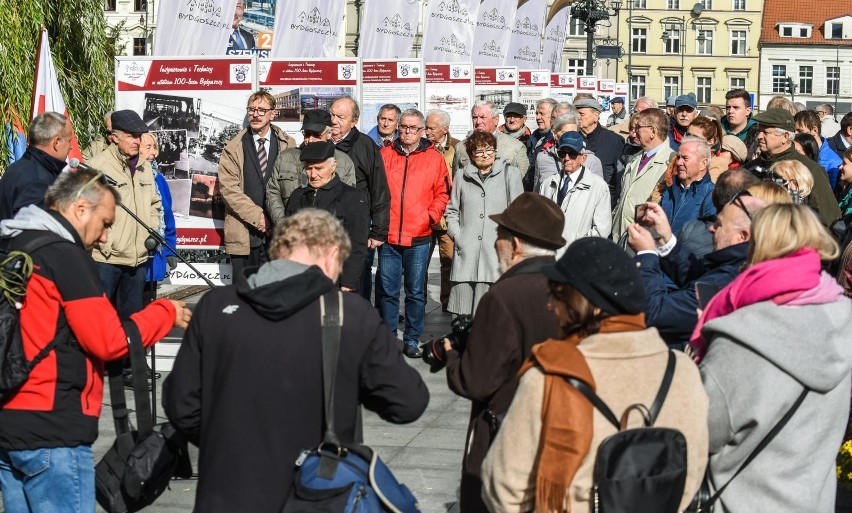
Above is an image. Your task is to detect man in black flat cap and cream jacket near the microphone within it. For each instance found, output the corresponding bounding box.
[88,110,162,330]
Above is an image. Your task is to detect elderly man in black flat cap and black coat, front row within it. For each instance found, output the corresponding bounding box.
[286,141,370,292]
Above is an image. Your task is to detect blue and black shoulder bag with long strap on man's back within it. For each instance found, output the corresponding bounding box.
[281,290,420,513]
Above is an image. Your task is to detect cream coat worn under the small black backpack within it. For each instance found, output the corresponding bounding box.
[482,328,708,513]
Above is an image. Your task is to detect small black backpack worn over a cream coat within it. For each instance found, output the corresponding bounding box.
[565,351,687,513]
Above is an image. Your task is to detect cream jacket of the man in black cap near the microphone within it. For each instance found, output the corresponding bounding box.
[88,144,163,267]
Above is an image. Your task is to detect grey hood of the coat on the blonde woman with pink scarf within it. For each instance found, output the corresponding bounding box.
[702,297,852,393]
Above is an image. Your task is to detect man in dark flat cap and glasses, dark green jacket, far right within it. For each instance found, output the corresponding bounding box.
[746,109,840,226]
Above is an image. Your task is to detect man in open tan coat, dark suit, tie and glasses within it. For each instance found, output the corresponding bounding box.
[219,91,296,282]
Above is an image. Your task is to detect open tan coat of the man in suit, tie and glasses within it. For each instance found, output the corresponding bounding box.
[219,125,296,255]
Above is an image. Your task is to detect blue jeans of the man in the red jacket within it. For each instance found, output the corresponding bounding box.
[376,243,430,345]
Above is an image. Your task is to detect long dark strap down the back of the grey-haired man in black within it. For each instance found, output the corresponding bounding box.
[320,289,343,446]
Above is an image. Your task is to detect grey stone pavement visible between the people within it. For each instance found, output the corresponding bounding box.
[88,253,470,513]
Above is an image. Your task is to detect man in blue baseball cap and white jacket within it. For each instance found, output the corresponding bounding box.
[540,131,612,256]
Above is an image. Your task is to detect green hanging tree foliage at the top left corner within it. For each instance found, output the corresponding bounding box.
[0,0,115,172]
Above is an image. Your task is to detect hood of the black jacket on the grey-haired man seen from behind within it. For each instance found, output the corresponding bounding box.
[237,259,335,321]
